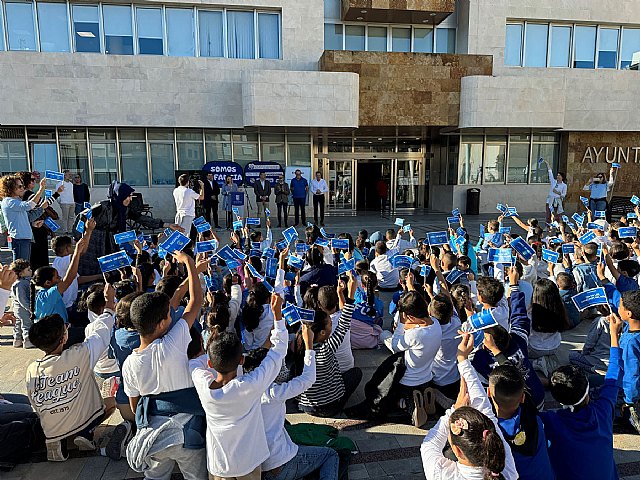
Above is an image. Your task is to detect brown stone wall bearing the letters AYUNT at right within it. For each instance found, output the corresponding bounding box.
[563,132,640,211]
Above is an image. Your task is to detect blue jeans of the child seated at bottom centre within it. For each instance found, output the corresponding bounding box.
[263,445,340,480]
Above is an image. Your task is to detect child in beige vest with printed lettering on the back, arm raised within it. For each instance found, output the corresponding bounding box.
[26,285,115,462]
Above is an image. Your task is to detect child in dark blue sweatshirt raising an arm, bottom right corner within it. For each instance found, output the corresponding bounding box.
[539,314,622,480]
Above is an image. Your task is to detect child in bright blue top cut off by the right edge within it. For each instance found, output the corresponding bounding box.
[618,290,640,433]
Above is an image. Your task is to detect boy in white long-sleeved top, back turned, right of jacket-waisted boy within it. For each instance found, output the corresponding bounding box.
[191,294,288,480]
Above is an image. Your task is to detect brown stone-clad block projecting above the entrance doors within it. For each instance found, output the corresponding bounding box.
[320,51,492,127]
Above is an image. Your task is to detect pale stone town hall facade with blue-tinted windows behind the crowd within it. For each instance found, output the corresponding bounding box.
[0,0,640,216]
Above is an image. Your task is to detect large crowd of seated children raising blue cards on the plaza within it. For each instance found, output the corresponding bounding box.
[0,190,640,480]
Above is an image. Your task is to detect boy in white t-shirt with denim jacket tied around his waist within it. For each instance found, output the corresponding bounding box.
[122,252,206,480]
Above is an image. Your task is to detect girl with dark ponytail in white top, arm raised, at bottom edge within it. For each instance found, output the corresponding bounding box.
[420,334,518,480]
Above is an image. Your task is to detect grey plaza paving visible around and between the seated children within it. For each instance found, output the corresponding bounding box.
[0,213,640,480]
